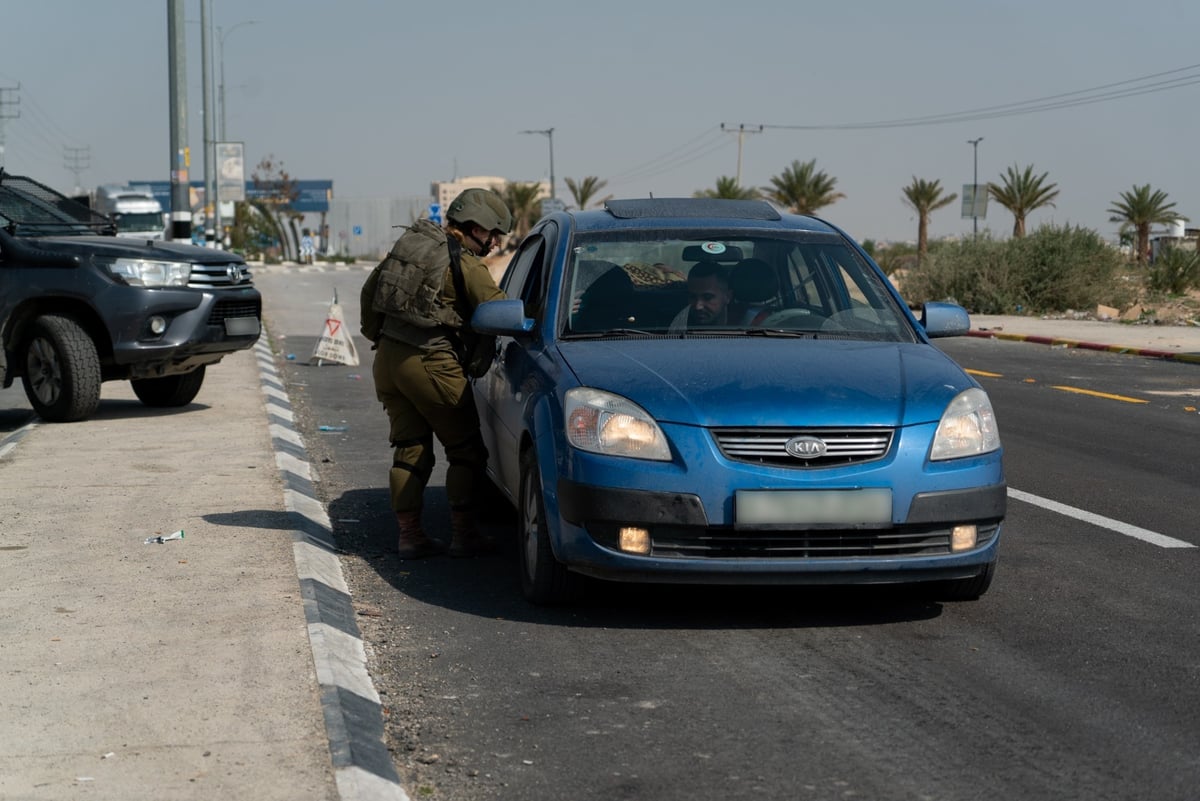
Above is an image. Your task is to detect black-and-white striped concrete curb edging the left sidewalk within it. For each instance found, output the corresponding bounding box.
[254,332,409,801]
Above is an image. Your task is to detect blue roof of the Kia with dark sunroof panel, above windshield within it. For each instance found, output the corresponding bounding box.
[559,198,839,234]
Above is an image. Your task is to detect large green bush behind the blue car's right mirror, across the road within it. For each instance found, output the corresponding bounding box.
[902,225,1134,314]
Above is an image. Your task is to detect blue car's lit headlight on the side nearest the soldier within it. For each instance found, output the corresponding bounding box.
[563,387,671,462]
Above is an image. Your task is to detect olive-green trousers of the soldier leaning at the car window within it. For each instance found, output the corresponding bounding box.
[372,337,487,512]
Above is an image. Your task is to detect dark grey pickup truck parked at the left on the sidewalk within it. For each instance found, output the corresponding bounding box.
[0,169,263,422]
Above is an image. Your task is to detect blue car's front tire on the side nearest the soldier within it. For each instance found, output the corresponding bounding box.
[517,448,582,606]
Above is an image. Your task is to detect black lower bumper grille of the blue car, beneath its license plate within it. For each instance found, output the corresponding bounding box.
[650,523,1000,559]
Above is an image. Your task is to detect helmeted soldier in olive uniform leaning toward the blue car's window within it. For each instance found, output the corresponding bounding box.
[361,189,512,559]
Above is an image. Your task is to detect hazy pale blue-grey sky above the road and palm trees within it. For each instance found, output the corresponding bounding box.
[0,0,1200,241]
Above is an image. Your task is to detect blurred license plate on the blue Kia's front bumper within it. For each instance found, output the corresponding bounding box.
[734,487,892,525]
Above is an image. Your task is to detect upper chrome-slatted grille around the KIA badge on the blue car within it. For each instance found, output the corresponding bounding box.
[713,428,894,470]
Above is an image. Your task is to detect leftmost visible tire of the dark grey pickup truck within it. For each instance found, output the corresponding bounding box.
[22,314,101,423]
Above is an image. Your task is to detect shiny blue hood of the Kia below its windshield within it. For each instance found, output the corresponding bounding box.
[558,338,974,427]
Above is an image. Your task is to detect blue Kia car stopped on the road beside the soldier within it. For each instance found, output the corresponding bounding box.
[472,198,1007,603]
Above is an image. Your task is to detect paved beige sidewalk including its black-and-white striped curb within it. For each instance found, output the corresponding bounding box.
[0,342,407,801]
